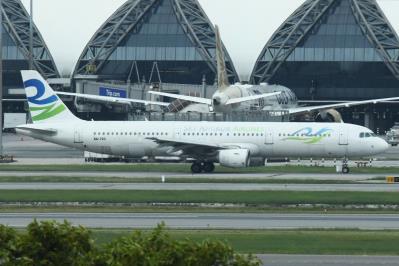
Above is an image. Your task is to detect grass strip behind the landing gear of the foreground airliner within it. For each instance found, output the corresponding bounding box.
[0,164,399,174]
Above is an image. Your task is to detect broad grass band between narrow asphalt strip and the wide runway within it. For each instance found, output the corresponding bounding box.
[0,190,399,206]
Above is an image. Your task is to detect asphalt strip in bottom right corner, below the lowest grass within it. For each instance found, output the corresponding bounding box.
[257,255,399,266]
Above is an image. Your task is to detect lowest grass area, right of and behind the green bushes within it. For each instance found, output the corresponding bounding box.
[93,230,399,255]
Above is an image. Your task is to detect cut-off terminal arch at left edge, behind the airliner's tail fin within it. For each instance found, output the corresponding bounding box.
[2,0,60,112]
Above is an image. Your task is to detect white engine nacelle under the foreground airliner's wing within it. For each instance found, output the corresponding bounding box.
[219,149,250,168]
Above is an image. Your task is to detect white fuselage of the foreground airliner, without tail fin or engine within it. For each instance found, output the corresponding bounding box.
[18,121,386,158]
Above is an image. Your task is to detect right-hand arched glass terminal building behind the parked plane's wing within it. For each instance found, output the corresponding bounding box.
[251,0,399,133]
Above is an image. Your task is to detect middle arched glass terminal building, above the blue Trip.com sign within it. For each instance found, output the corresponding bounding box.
[73,0,239,118]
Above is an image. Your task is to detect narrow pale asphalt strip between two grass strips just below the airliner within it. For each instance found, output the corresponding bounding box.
[0,183,399,192]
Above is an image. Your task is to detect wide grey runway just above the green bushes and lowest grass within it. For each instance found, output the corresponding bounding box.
[0,213,399,230]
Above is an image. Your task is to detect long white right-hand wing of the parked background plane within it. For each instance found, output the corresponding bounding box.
[288,97,399,114]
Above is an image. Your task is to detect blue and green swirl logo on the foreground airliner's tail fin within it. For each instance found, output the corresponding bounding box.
[24,79,66,121]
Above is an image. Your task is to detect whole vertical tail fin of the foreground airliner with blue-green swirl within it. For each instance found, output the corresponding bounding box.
[21,70,79,124]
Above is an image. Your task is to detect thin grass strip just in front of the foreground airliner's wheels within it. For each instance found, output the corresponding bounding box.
[0,175,359,184]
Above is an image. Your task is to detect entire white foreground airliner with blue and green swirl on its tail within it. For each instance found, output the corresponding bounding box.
[17,70,388,173]
